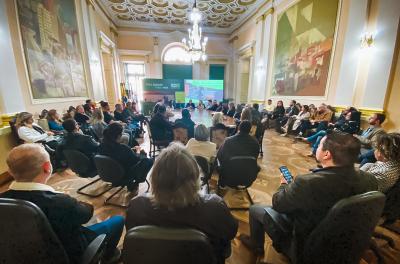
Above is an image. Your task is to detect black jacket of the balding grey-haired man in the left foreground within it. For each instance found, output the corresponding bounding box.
[0,190,96,263]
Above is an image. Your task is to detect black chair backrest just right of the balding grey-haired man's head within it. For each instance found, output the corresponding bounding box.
[63,149,93,177]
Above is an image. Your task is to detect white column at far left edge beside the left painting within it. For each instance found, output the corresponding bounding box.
[0,0,25,113]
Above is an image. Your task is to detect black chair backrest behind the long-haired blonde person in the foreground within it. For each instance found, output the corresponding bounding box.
[122,226,216,264]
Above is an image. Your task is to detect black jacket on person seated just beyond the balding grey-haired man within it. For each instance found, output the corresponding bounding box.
[57,133,99,158]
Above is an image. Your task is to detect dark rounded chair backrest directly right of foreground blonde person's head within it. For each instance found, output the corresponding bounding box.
[220,156,260,188]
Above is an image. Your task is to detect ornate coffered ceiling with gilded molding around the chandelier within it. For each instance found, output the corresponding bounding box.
[97,0,270,34]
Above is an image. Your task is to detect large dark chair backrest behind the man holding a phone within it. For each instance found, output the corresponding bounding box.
[303,191,385,264]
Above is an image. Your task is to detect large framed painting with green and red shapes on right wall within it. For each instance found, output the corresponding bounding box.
[272,0,339,96]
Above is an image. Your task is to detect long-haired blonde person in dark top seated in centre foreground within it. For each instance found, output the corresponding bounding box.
[126,143,238,263]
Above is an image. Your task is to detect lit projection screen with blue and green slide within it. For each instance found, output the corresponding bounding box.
[185,80,224,104]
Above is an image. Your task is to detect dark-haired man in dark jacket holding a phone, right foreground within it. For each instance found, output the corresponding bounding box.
[239,132,377,263]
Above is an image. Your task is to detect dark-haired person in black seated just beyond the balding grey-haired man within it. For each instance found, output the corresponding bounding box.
[57,119,99,159]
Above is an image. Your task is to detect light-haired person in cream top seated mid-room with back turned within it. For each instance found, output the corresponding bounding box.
[186,124,217,161]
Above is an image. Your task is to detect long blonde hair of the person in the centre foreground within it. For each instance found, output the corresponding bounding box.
[150,143,200,210]
